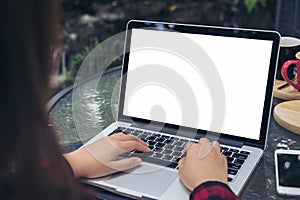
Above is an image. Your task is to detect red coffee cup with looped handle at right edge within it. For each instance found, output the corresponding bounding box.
[281,51,300,91]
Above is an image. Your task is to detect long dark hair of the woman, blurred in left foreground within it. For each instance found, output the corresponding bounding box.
[0,0,88,199]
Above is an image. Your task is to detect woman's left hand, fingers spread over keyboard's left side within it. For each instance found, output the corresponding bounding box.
[63,133,150,178]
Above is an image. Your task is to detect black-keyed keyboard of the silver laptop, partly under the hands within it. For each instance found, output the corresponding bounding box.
[112,127,251,182]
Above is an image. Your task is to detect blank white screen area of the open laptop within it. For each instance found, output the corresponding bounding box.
[123,29,272,140]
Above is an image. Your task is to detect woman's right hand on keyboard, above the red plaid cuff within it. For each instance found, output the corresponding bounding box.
[178,138,227,191]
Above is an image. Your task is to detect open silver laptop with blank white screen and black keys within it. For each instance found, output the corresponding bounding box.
[82,20,280,199]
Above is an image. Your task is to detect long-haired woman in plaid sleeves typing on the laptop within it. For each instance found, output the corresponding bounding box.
[0,0,237,199]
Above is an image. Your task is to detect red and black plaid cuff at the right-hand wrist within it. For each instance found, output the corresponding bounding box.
[190,181,239,200]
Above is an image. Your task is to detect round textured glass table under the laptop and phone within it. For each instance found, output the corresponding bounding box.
[48,67,300,199]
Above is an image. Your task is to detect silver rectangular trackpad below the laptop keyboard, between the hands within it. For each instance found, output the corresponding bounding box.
[105,164,178,197]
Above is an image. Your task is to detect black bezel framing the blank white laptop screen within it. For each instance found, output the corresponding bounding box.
[118,20,280,149]
